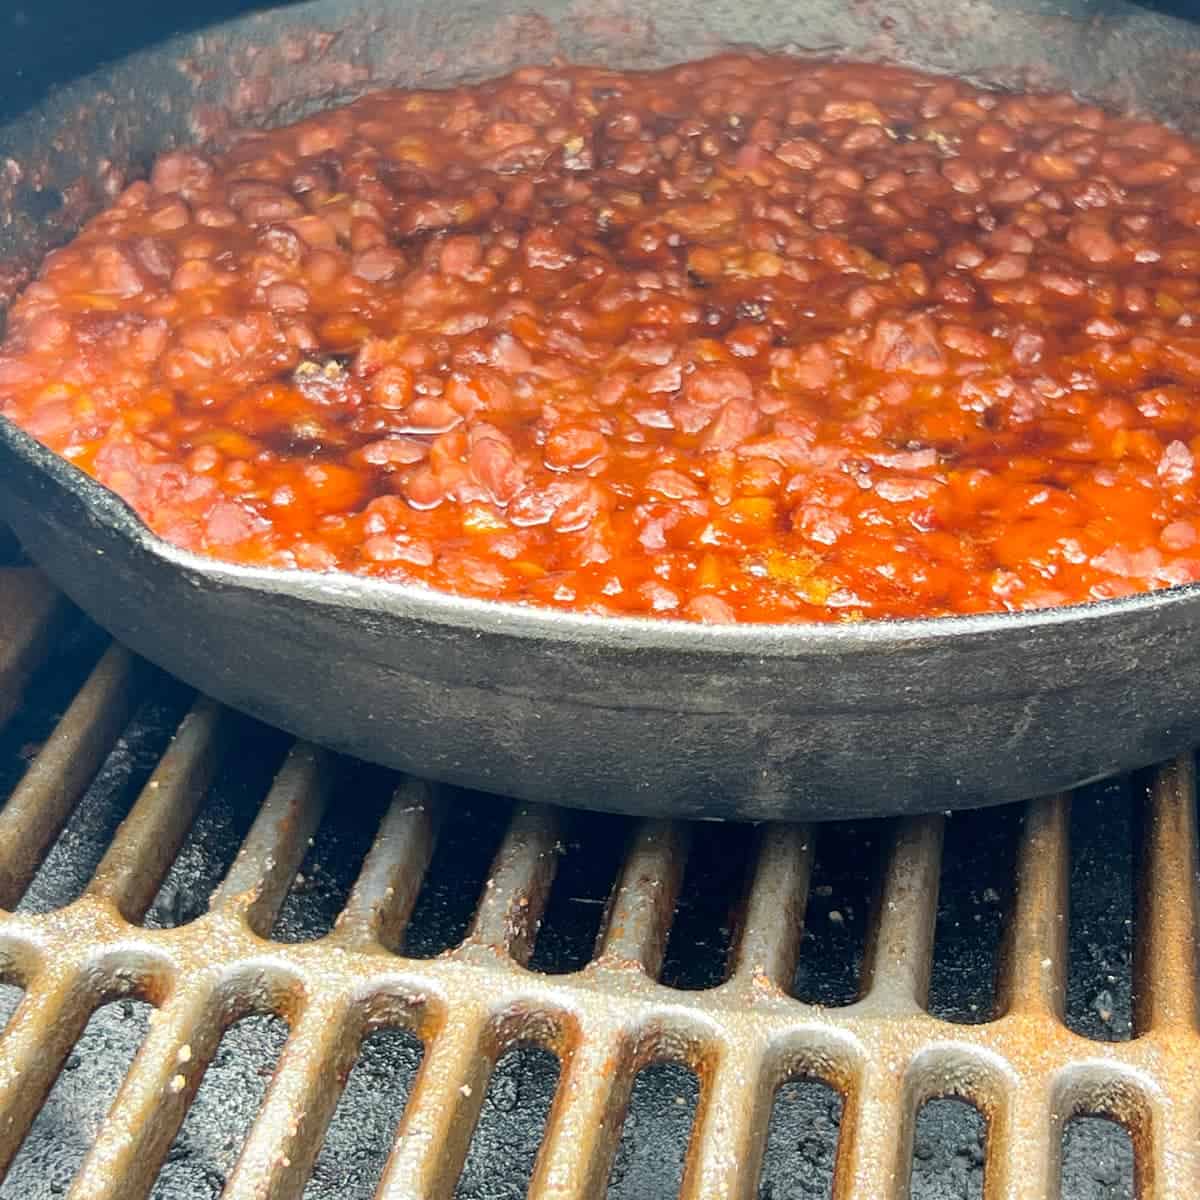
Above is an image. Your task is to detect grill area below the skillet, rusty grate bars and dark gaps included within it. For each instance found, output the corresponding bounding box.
[0,552,1185,1200]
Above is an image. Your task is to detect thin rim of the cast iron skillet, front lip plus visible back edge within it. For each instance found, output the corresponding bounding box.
[0,0,1200,660]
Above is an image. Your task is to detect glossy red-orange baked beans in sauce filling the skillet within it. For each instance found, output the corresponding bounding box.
[0,55,1200,622]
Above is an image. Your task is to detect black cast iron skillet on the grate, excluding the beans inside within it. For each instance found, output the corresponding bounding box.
[0,0,1200,818]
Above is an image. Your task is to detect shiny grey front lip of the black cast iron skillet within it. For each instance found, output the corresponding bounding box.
[0,414,1200,659]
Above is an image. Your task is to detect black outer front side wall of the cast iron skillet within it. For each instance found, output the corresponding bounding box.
[0,428,1200,820]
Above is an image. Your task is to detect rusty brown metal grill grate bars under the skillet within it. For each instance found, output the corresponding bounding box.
[0,569,1200,1200]
